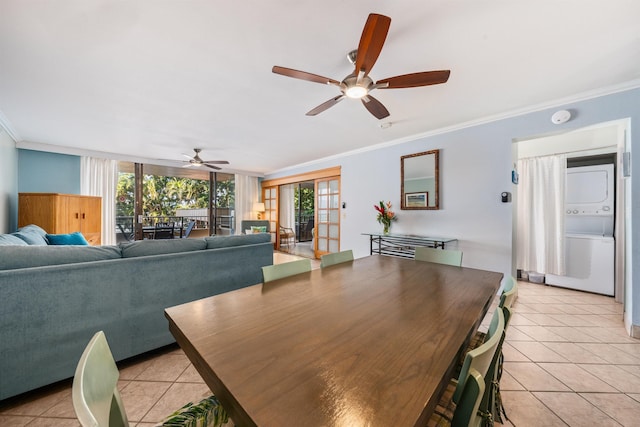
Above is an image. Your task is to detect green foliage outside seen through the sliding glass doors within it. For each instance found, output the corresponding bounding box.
[116,173,235,217]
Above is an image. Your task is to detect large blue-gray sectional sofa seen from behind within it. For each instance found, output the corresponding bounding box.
[0,226,273,400]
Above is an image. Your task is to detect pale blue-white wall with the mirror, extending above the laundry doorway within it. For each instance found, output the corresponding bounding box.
[266,89,640,300]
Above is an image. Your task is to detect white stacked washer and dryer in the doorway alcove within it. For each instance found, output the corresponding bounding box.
[545,164,615,296]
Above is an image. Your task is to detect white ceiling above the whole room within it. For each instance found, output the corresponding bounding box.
[0,0,640,174]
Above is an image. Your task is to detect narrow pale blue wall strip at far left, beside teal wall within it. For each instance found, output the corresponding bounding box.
[0,127,18,233]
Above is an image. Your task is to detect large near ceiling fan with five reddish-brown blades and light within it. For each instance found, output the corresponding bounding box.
[271,13,451,119]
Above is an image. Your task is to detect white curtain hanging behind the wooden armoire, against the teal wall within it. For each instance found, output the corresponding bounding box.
[80,157,118,245]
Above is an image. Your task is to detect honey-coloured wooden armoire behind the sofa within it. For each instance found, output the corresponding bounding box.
[18,193,102,245]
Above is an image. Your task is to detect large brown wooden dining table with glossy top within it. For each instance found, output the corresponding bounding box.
[165,255,502,427]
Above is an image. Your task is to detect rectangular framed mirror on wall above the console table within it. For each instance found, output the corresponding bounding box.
[400,150,440,210]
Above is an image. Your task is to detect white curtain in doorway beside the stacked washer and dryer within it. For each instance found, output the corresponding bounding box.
[516,155,567,275]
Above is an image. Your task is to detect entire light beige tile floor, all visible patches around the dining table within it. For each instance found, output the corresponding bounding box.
[0,276,640,427]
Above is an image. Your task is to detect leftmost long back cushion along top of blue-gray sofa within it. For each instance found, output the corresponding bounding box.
[0,246,122,270]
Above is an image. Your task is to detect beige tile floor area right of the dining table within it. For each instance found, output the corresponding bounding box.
[500,282,640,427]
